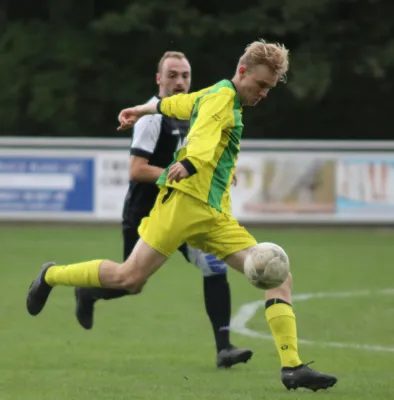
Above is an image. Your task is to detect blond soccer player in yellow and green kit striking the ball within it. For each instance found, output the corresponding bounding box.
[27,41,337,390]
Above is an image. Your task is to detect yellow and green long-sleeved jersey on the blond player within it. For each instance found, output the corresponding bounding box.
[157,80,243,213]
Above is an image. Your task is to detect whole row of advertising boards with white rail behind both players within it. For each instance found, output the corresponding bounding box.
[0,138,394,224]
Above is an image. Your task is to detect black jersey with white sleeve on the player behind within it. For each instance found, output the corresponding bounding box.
[123,96,189,222]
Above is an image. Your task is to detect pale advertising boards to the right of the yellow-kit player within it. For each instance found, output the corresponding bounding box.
[232,151,394,223]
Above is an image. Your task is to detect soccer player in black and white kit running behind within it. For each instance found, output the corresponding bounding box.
[75,51,253,368]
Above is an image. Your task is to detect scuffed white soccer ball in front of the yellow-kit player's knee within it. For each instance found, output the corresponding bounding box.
[244,242,290,289]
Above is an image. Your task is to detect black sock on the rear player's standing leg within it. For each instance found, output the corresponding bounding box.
[204,274,231,352]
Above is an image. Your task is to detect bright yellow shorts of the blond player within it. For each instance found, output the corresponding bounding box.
[138,187,257,260]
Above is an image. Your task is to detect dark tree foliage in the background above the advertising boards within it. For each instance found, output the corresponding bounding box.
[0,0,394,138]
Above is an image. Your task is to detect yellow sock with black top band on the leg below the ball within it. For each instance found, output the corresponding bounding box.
[265,299,302,367]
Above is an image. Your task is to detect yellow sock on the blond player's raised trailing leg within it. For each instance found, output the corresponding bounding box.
[44,260,103,287]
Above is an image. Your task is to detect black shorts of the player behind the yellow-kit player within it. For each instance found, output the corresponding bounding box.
[122,210,190,262]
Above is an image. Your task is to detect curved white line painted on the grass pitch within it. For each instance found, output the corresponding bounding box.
[231,289,394,352]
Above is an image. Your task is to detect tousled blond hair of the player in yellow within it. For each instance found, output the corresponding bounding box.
[239,39,289,82]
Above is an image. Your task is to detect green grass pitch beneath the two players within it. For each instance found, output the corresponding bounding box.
[0,225,394,400]
